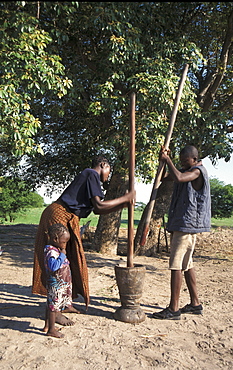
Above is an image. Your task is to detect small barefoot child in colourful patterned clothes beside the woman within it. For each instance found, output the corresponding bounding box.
[43,223,72,338]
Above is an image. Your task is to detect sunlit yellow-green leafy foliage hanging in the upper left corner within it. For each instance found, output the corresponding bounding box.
[0,2,72,167]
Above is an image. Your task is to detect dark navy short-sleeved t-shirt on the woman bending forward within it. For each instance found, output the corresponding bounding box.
[59,168,104,218]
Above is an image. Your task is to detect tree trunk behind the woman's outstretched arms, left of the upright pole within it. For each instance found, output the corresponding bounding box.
[94,173,129,256]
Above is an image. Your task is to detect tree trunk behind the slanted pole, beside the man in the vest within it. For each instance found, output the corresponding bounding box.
[134,181,173,256]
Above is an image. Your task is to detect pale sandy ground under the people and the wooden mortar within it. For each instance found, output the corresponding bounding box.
[0,225,233,370]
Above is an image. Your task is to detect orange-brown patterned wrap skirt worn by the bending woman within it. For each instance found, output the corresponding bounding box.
[32,201,90,309]
